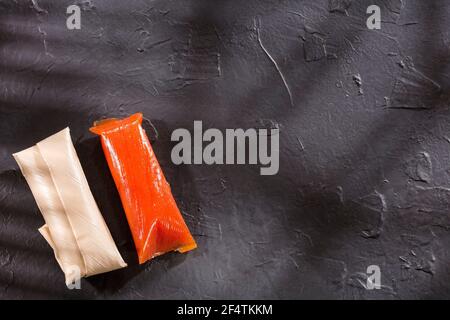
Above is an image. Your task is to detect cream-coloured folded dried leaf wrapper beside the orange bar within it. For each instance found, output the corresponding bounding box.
[13,128,127,284]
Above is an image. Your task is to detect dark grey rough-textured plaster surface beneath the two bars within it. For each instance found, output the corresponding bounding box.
[0,0,450,299]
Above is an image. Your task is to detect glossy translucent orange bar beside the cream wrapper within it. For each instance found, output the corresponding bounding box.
[90,113,197,264]
